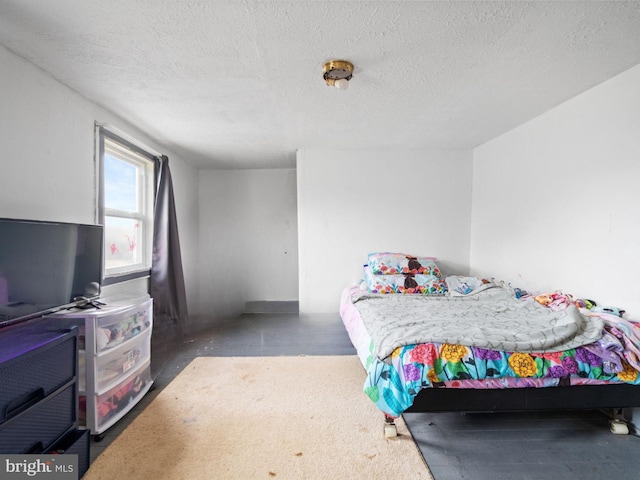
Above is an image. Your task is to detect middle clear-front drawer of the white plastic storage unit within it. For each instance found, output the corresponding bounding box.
[96,328,151,390]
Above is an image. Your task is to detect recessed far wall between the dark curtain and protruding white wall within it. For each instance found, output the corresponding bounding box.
[198,169,298,321]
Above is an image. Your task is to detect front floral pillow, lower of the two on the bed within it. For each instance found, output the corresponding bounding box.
[364,265,447,295]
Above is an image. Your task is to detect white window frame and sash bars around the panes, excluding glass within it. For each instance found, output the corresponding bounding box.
[96,124,158,285]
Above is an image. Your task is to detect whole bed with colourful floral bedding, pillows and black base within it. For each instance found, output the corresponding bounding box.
[340,252,640,436]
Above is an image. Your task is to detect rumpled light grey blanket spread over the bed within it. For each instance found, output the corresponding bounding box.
[351,286,604,360]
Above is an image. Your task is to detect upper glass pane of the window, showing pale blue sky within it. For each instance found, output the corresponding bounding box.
[104,152,139,212]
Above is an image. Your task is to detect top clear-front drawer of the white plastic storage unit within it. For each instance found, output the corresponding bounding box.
[95,300,153,353]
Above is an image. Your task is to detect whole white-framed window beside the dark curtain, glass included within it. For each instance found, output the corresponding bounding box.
[98,128,154,284]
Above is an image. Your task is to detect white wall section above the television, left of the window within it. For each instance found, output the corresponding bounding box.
[0,46,97,223]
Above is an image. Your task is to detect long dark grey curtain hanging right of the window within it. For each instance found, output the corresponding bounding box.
[151,155,188,366]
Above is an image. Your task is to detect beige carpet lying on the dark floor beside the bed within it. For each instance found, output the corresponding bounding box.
[84,356,432,480]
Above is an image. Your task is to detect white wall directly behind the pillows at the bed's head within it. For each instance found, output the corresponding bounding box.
[297,150,472,313]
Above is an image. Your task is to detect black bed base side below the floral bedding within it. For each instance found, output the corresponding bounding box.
[406,384,640,413]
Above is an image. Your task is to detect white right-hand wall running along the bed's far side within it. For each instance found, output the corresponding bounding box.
[471,62,640,319]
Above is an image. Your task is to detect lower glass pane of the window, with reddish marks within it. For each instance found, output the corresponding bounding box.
[105,216,144,269]
